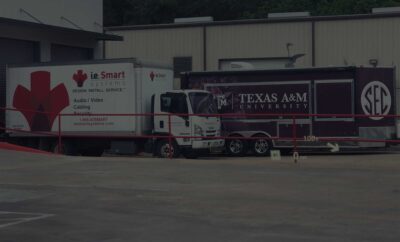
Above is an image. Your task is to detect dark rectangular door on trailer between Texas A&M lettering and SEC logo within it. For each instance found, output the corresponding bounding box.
[313,79,358,137]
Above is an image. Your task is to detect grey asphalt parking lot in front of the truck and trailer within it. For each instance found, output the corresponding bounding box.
[0,151,400,242]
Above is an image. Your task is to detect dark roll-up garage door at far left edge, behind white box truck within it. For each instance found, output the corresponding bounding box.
[0,38,40,132]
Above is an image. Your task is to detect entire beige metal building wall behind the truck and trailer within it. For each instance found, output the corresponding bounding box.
[106,16,400,99]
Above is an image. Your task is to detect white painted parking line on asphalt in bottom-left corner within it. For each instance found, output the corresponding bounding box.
[0,211,54,229]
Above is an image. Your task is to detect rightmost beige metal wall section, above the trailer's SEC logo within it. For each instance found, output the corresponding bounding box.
[315,17,400,113]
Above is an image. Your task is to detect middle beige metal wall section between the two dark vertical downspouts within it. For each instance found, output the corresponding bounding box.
[207,22,312,70]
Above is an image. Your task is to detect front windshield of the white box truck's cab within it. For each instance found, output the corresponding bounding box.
[189,92,217,114]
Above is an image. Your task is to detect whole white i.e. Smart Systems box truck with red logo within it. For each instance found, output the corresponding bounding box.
[6,59,224,157]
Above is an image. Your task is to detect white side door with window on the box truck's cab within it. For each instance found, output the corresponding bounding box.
[154,93,191,145]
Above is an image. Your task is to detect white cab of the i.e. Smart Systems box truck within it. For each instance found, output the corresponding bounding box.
[152,90,224,158]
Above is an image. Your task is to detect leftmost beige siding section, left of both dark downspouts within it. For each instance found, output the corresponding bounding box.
[106,27,203,71]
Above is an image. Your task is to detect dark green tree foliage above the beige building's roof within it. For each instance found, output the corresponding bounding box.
[104,0,400,26]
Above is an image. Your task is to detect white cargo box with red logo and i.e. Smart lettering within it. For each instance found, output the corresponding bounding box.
[6,60,173,135]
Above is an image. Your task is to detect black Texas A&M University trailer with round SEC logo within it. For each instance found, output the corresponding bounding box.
[181,67,396,155]
